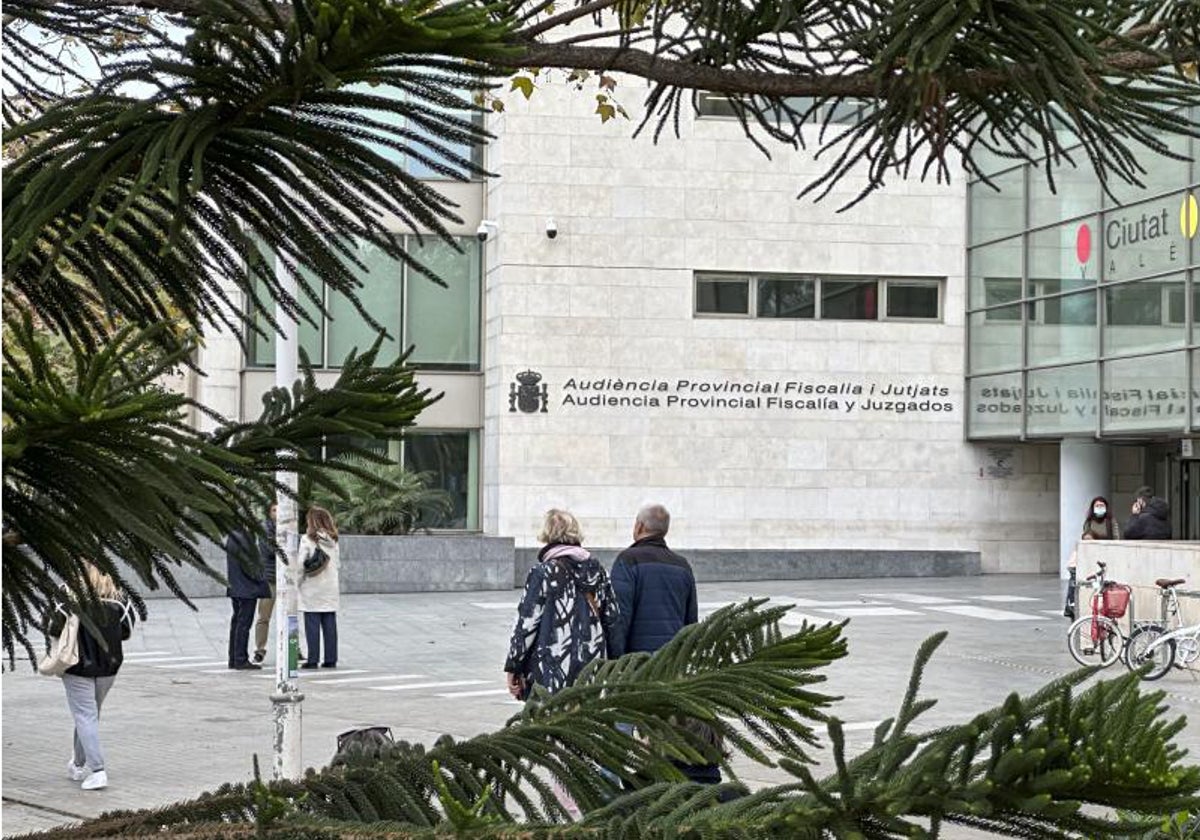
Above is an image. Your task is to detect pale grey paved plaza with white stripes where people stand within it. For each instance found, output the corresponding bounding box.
[2,576,1200,836]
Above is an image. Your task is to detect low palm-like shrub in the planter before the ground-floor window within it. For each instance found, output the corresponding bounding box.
[312,457,454,535]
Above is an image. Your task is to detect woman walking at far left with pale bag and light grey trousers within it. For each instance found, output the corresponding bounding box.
[46,563,134,791]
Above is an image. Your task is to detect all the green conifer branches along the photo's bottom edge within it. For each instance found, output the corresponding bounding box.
[16,601,1200,840]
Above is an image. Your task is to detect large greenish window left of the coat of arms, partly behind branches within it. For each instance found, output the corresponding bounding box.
[250,235,481,371]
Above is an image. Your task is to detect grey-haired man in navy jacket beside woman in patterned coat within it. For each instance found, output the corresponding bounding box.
[612,504,697,655]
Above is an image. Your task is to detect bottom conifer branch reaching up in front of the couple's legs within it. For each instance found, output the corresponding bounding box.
[18,601,845,838]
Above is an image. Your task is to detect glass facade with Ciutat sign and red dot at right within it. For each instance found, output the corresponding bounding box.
[966,131,1200,439]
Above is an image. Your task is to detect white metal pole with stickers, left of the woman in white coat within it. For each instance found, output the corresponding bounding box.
[271,256,304,779]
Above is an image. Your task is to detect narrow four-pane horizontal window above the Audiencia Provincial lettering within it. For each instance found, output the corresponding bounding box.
[696,274,942,320]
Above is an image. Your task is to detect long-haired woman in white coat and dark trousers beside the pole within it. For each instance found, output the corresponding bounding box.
[299,505,341,668]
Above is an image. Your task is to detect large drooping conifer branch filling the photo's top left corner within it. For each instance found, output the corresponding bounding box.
[4,0,509,346]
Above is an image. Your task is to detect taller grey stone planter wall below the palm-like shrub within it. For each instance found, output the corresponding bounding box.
[139,534,515,598]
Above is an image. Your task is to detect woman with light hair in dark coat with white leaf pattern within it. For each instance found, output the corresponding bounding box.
[504,509,620,700]
